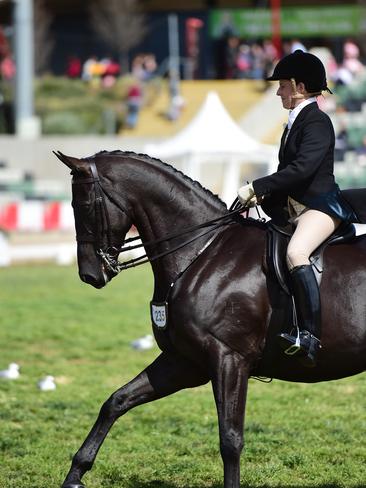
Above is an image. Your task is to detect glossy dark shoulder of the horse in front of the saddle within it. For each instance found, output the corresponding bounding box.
[171,225,269,357]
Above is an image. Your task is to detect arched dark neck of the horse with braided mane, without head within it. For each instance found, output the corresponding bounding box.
[117,156,227,283]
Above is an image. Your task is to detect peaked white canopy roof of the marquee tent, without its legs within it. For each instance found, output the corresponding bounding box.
[145,91,273,161]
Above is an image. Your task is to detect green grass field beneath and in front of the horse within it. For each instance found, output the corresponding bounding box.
[0,266,366,488]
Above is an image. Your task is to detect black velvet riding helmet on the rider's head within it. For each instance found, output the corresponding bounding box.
[267,49,332,93]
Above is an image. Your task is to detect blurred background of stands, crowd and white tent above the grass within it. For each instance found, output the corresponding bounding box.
[0,0,366,266]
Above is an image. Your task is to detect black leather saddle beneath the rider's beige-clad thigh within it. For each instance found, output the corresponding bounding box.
[266,221,356,295]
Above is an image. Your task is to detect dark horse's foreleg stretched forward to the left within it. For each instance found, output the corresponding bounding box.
[62,353,209,488]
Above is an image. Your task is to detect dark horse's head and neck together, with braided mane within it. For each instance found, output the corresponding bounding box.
[55,151,227,288]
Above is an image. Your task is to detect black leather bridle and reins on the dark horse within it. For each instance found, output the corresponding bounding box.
[72,160,248,274]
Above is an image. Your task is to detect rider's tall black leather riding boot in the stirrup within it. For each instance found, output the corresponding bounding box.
[278,265,321,367]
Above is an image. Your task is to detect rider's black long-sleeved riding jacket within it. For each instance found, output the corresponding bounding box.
[253,102,354,225]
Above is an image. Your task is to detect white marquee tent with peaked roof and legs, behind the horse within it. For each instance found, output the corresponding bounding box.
[144,92,277,203]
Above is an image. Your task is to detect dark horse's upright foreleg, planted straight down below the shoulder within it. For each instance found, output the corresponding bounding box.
[212,346,249,488]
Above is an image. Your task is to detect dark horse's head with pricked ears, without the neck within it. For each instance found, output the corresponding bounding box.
[54,152,132,288]
